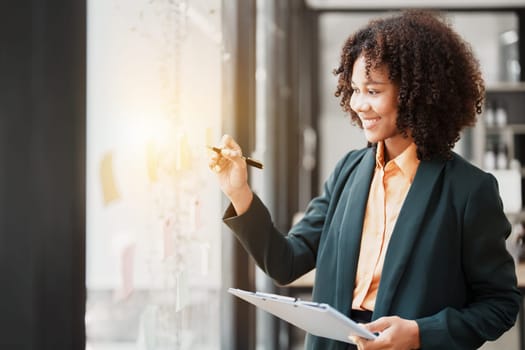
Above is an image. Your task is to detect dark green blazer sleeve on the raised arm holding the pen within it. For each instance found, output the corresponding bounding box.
[223,152,352,285]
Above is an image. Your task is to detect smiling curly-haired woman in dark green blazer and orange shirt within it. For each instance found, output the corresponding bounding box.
[210,11,521,350]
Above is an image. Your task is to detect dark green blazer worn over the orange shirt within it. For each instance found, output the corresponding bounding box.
[224,147,521,350]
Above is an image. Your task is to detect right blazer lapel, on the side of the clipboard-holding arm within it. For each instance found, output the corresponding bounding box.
[373,161,445,319]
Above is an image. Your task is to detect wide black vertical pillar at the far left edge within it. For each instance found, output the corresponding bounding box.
[0,0,86,350]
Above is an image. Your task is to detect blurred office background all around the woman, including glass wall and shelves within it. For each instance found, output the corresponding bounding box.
[0,0,525,350]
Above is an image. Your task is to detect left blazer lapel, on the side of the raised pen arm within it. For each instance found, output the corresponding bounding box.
[336,148,375,311]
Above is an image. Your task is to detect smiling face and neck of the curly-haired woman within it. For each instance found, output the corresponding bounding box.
[350,55,412,159]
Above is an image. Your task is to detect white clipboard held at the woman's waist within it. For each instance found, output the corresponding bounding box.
[228,288,377,344]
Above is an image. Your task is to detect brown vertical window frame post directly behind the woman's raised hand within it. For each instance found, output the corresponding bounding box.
[221,0,256,350]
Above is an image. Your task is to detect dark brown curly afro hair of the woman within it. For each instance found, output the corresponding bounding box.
[334,10,485,160]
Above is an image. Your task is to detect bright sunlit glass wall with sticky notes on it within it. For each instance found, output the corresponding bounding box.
[86,0,223,350]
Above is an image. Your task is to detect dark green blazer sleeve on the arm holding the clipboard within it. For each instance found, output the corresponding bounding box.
[416,174,521,350]
